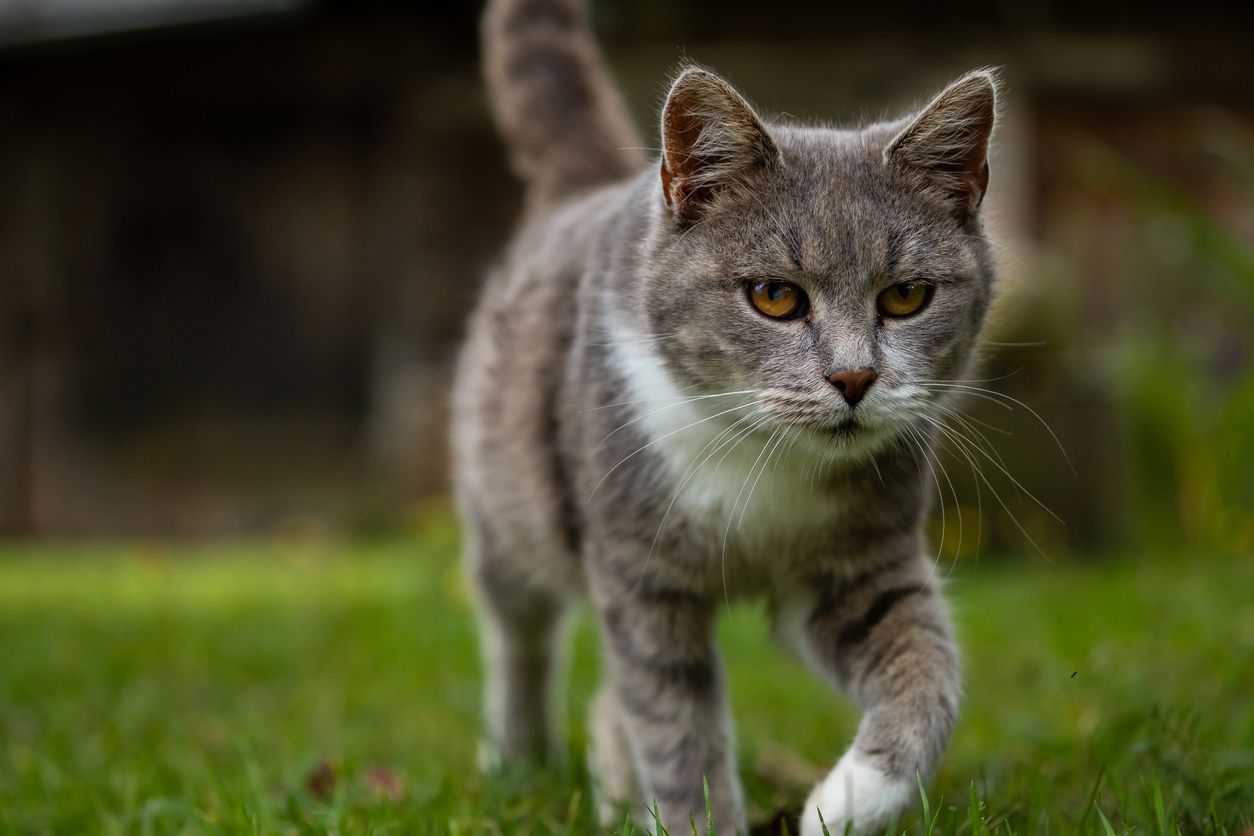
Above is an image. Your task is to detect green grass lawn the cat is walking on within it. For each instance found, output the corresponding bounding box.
[0,524,1254,835]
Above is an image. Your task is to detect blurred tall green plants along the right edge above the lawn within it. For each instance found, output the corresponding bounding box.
[1086,147,1254,554]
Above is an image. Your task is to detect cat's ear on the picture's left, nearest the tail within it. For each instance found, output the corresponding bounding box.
[662,69,779,222]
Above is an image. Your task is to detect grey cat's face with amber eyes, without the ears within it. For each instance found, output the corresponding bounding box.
[640,69,992,455]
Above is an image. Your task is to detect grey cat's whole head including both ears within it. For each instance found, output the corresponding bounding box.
[632,69,997,454]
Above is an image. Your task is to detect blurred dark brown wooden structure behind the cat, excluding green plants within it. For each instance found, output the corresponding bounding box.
[0,0,1254,544]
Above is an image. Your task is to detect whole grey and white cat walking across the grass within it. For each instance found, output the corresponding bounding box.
[454,0,997,836]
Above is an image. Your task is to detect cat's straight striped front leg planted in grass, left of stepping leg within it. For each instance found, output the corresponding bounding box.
[592,555,746,833]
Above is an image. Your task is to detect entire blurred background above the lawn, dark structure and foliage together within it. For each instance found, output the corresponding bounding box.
[0,0,1254,554]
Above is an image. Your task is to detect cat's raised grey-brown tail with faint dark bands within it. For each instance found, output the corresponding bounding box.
[483,0,645,213]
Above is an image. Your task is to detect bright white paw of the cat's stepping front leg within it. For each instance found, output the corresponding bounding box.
[801,750,918,836]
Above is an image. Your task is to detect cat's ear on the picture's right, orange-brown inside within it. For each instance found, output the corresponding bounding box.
[884,69,998,218]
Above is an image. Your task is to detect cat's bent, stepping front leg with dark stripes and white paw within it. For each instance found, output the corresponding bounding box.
[776,558,961,836]
